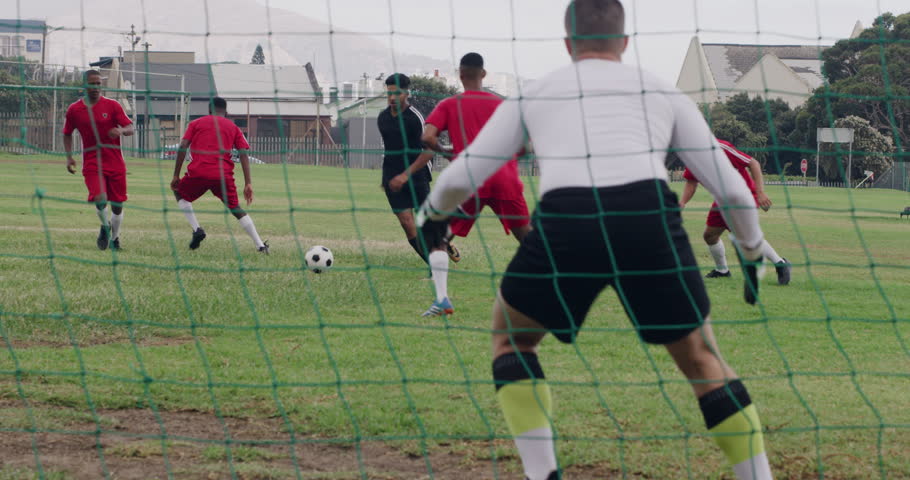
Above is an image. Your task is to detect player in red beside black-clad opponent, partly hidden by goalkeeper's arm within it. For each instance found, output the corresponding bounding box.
[389,52,531,316]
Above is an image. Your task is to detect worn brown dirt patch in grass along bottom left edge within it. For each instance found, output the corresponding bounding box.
[0,400,618,480]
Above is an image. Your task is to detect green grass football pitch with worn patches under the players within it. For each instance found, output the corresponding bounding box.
[0,156,910,479]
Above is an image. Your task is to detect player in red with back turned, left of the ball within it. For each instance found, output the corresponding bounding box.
[171,97,269,255]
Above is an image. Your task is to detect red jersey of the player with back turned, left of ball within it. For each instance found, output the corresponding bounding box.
[183,115,250,179]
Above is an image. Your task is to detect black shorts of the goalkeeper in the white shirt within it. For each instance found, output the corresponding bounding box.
[501,180,710,344]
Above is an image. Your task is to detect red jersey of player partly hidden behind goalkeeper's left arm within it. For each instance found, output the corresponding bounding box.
[427,90,524,200]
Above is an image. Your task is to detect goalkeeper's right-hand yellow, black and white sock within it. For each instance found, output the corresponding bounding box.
[698,380,771,480]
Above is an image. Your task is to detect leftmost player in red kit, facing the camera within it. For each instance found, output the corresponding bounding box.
[63,70,134,250]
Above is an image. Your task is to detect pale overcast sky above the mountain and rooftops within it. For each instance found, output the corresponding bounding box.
[257,0,910,83]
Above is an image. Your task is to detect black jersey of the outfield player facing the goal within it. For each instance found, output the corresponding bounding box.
[376,107,431,183]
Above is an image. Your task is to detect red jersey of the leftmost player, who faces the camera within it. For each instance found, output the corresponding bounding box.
[63,97,133,173]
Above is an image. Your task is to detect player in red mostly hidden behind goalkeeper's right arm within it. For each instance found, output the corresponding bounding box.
[679,139,791,285]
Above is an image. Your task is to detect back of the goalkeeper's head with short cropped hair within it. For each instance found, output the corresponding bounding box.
[565,0,626,52]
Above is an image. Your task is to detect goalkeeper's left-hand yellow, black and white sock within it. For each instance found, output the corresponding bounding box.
[493,352,559,480]
